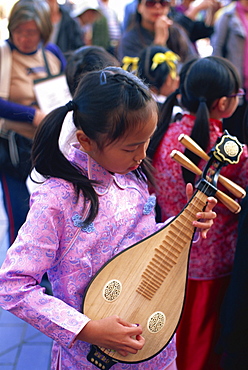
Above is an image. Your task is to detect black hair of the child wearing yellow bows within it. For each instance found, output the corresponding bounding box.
[138,45,176,91]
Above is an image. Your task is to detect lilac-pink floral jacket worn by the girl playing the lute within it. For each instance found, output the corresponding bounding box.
[0,147,176,370]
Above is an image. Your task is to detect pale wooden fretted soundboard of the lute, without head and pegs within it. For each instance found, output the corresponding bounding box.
[83,191,207,363]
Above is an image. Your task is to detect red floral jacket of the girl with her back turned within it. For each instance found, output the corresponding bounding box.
[153,114,248,279]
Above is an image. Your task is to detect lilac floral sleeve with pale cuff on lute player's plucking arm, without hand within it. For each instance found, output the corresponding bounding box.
[0,181,90,348]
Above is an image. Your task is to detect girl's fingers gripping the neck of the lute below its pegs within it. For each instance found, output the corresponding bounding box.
[186,184,217,239]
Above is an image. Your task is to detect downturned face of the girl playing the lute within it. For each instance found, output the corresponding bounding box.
[82,106,158,175]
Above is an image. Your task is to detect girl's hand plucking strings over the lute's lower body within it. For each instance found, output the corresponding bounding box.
[77,316,145,357]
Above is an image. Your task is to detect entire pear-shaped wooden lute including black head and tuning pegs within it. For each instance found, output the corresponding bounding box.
[83,131,245,370]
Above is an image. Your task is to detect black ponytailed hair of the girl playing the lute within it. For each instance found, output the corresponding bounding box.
[32,67,157,225]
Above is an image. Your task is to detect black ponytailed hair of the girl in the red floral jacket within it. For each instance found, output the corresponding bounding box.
[150,56,241,184]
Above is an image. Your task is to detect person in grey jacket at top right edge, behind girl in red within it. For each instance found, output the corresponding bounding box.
[211,0,248,143]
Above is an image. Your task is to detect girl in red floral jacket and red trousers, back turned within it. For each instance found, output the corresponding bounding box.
[147,56,248,370]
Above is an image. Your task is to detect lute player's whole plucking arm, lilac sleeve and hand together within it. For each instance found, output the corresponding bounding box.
[0,179,145,356]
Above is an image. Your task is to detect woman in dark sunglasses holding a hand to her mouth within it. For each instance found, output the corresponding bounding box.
[119,0,197,62]
